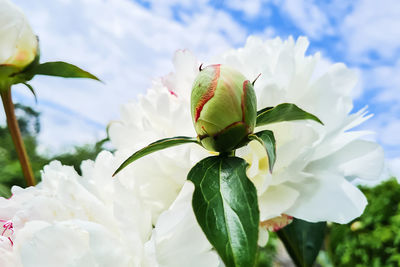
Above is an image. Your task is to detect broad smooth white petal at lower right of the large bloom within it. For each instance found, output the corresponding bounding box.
[286,172,367,224]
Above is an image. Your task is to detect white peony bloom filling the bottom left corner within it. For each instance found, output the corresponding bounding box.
[0,152,219,267]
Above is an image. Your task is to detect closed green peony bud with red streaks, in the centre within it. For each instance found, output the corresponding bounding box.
[191,64,257,152]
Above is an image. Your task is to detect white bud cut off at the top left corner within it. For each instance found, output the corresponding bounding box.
[0,0,38,68]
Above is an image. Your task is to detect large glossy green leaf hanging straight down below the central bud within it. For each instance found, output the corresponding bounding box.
[188,156,260,267]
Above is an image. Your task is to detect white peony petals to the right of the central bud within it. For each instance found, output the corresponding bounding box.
[218,38,383,223]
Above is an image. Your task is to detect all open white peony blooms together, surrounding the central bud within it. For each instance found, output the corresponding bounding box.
[0,5,383,267]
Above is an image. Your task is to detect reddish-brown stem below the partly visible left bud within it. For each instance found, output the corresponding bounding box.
[0,88,36,186]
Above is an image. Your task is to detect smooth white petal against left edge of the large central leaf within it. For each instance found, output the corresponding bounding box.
[146,182,220,267]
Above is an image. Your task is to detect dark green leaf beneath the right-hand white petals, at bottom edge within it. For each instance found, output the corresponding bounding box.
[277,218,326,267]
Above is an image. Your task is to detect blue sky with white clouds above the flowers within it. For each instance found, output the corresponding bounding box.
[0,0,400,178]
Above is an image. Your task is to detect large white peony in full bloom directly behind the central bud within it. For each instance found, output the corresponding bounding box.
[110,37,383,226]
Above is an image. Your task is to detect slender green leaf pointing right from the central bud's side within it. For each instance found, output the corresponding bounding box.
[256,103,323,126]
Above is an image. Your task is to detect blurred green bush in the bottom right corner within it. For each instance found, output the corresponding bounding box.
[328,178,400,267]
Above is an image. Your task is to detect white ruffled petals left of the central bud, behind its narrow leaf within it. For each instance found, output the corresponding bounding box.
[109,50,209,224]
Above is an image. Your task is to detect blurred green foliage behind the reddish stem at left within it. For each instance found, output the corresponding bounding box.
[0,104,105,197]
